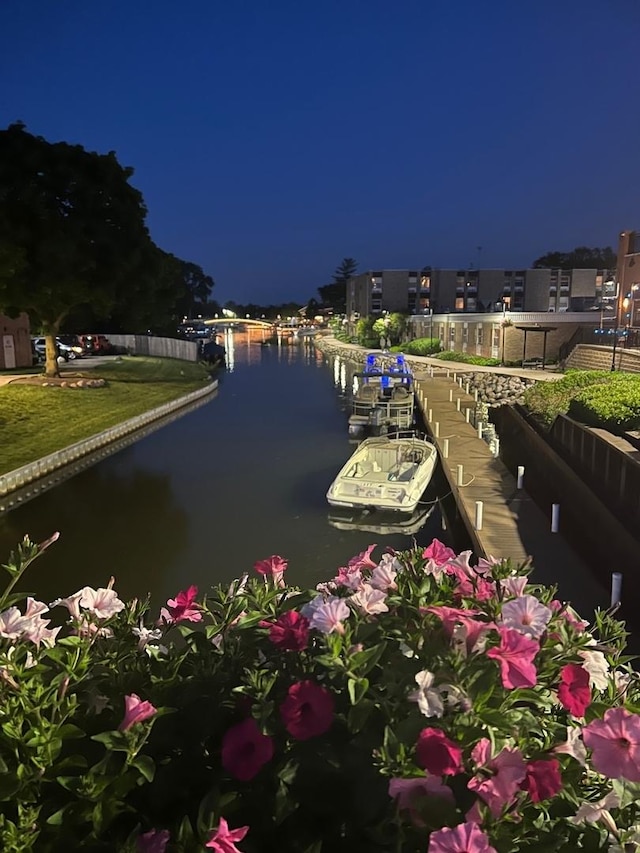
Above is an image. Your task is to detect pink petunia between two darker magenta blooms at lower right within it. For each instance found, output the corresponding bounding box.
[467,738,526,817]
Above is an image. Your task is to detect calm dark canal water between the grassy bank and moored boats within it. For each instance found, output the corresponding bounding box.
[0,333,460,606]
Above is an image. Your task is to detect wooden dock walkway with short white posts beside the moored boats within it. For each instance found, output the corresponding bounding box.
[415,368,609,612]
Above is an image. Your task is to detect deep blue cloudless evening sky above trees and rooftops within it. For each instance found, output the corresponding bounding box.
[0,0,640,304]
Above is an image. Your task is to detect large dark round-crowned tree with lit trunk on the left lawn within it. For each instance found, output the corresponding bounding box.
[0,123,158,376]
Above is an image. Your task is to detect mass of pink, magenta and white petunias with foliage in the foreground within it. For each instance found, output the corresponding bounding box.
[0,537,640,853]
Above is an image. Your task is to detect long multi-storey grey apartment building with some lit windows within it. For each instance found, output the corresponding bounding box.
[347,264,616,317]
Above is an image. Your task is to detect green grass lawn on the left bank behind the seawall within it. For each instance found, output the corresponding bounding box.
[0,356,215,474]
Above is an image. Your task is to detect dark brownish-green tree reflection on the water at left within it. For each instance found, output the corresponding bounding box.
[0,462,189,601]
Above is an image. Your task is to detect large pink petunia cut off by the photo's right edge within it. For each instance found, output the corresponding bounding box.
[582,708,640,782]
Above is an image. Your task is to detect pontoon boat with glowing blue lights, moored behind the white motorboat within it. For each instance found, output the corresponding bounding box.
[349,353,415,436]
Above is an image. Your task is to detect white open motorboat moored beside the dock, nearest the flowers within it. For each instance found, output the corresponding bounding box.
[327,433,438,513]
